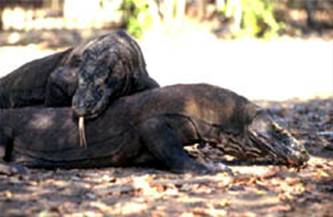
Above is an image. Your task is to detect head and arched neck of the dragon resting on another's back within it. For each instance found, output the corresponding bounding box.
[70,31,146,119]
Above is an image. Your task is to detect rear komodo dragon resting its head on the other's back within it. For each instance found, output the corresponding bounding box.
[0,30,159,118]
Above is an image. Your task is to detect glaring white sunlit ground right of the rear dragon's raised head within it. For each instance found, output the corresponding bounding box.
[142,27,333,100]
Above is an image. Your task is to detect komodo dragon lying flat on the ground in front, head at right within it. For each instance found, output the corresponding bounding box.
[0,84,309,173]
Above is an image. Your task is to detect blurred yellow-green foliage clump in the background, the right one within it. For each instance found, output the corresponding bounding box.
[222,0,283,38]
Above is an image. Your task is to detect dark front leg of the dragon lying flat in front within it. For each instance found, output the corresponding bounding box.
[140,118,210,173]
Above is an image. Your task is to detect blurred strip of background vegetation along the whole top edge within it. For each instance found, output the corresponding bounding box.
[0,0,333,38]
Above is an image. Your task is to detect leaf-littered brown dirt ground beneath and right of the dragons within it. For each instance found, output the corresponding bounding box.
[0,98,333,217]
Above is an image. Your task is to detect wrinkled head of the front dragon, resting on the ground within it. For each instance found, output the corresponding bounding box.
[219,110,309,167]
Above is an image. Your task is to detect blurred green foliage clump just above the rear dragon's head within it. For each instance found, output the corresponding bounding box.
[121,0,153,37]
